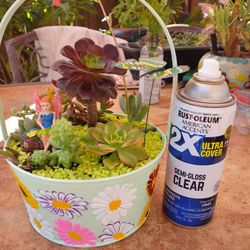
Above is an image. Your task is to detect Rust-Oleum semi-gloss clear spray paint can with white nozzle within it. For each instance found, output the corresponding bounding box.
[163,59,236,227]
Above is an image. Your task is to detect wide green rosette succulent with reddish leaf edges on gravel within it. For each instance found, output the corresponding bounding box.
[85,121,148,168]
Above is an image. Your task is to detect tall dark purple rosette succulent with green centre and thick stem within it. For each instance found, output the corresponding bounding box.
[52,38,126,126]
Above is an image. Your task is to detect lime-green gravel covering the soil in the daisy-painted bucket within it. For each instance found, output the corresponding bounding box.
[9,120,163,180]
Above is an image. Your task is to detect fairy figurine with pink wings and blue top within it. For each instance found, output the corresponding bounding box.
[34,89,62,151]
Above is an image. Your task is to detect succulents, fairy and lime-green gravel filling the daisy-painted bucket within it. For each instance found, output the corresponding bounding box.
[0,38,163,179]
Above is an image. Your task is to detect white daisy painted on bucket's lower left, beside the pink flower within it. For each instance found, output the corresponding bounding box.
[26,205,54,238]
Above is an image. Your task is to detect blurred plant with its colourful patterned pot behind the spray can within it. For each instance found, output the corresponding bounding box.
[199,0,250,89]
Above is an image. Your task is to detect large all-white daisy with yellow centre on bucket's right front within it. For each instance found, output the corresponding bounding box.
[91,184,137,225]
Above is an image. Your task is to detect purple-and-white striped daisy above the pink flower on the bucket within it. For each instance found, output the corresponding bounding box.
[35,190,88,219]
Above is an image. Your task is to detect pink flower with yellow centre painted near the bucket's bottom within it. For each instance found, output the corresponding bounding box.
[54,219,96,246]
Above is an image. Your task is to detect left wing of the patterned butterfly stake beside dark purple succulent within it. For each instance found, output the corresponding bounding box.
[115,58,166,72]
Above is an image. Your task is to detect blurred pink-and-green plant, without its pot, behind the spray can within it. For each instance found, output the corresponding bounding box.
[199,0,250,57]
